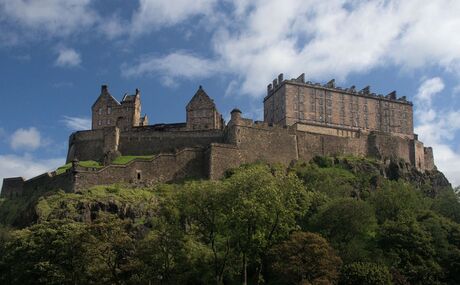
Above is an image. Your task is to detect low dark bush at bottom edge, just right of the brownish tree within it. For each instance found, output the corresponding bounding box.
[339,262,392,285]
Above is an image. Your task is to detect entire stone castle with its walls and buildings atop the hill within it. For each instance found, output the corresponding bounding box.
[1,74,435,197]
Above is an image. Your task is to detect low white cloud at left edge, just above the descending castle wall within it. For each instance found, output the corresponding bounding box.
[0,155,65,190]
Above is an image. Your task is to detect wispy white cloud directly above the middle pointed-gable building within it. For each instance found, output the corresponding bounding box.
[122,51,219,80]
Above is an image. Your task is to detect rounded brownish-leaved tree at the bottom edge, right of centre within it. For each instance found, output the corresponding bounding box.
[271,232,342,284]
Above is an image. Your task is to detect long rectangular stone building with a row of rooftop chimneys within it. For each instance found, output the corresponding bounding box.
[264,74,414,137]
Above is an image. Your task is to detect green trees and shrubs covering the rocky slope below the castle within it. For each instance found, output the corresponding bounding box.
[0,157,460,284]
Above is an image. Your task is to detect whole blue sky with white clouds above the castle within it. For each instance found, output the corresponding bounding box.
[0,0,460,186]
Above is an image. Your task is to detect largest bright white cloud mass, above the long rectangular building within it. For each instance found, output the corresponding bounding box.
[121,0,460,96]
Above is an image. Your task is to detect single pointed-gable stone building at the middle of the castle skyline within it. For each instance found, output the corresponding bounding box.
[186,86,224,130]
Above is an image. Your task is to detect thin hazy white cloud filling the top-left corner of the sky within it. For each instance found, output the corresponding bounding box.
[0,0,98,36]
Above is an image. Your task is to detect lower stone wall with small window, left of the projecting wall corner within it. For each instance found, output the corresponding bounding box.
[75,148,207,191]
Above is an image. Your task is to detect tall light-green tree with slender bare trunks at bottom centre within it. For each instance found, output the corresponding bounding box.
[224,164,304,284]
